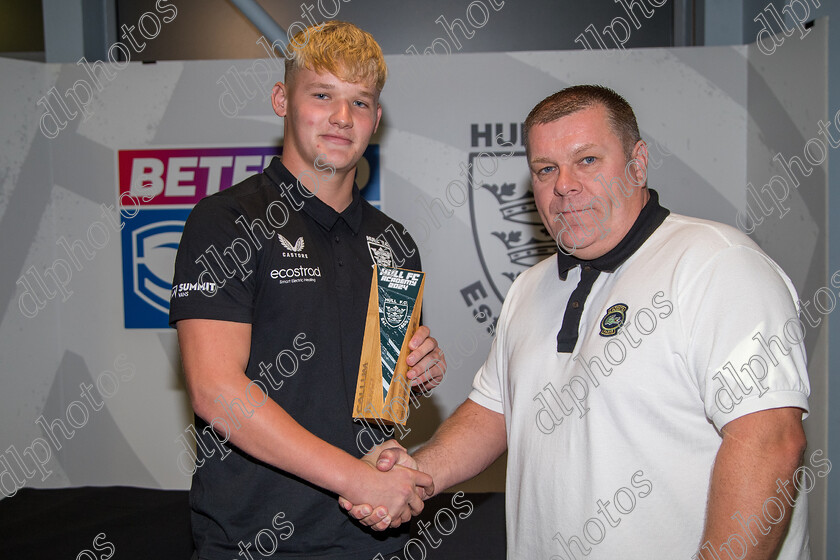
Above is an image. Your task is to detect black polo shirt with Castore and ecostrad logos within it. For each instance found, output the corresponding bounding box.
[169,158,420,560]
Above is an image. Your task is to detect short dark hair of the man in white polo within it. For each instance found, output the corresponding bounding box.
[522,85,642,160]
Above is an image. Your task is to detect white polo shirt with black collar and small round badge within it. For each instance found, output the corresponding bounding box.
[470,198,809,560]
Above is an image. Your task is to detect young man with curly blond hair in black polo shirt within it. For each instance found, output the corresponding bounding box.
[170,22,445,560]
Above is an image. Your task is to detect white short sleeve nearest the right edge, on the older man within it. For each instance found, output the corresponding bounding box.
[678,245,810,430]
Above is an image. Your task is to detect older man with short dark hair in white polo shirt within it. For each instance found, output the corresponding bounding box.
[342,86,809,560]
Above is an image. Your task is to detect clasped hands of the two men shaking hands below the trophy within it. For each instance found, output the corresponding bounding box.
[338,440,435,531]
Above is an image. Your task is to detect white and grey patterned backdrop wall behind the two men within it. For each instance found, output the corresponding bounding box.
[0,29,836,556]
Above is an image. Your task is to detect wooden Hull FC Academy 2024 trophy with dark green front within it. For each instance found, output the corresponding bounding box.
[353,265,425,424]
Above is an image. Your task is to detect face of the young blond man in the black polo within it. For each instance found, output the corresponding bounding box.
[272,68,382,178]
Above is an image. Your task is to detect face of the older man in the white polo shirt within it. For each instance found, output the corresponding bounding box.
[528,105,649,260]
